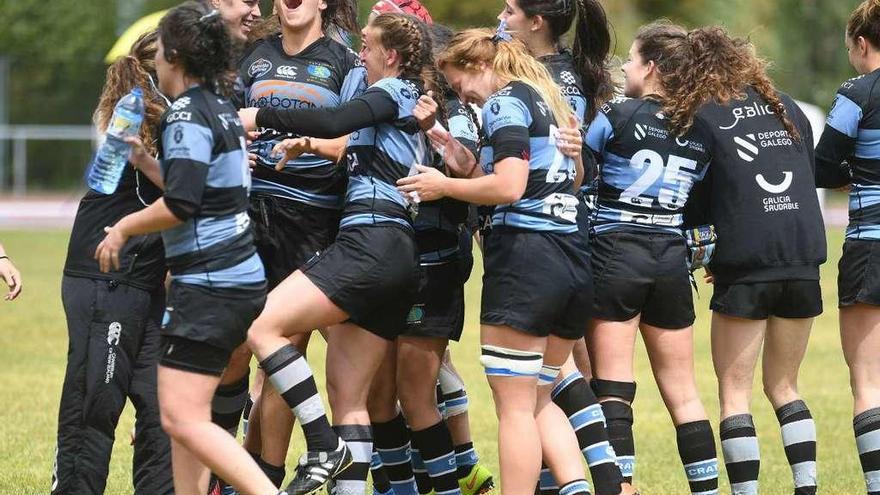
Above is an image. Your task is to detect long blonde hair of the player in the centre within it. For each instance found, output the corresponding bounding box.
[437,29,574,126]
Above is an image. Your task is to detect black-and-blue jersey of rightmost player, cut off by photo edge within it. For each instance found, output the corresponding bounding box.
[816,69,880,240]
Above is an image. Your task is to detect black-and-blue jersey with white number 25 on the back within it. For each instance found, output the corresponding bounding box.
[587,97,710,234]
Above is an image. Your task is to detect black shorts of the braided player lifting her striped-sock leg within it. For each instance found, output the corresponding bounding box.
[302,225,419,340]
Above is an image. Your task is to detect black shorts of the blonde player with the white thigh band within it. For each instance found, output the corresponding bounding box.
[480,228,593,340]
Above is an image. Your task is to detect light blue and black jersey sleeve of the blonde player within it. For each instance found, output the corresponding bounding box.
[483,96,532,163]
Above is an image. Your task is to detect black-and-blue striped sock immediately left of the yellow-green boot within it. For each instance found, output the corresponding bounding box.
[412,420,461,495]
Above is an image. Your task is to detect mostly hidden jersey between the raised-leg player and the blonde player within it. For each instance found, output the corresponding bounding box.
[413,98,480,264]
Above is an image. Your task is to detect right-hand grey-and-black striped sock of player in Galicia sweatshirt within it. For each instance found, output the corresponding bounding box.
[776,400,817,495]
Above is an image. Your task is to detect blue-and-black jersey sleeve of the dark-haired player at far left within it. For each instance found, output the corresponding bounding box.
[162,106,214,221]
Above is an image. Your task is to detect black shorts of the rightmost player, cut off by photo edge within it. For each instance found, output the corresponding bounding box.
[837,239,880,306]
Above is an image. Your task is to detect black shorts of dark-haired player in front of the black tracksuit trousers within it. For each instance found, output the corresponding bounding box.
[161,282,266,375]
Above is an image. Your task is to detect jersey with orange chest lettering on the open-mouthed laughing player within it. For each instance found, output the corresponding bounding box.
[240,36,366,209]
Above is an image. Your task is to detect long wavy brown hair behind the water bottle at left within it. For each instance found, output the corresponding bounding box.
[92,31,166,154]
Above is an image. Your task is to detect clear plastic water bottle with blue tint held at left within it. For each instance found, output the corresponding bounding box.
[87,88,144,194]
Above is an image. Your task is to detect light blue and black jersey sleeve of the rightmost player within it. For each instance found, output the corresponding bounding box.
[815,88,863,187]
